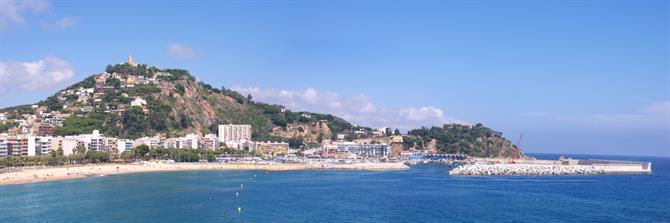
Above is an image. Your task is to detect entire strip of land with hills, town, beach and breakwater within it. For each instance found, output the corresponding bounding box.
[0,56,651,183]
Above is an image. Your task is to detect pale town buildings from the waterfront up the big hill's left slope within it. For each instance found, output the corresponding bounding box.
[0,56,420,160]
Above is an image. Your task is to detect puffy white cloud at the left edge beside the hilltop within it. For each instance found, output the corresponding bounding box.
[0,56,74,92]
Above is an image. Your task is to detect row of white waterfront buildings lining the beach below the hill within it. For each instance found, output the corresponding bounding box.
[0,124,400,160]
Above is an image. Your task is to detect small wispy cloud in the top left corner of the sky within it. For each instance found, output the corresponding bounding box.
[0,0,51,30]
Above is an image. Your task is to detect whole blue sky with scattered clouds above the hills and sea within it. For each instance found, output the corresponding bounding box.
[0,0,670,156]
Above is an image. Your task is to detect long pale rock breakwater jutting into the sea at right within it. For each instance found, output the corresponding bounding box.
[449,160,651,176]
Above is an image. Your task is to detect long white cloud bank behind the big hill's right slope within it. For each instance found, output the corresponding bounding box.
[232,86,467,130]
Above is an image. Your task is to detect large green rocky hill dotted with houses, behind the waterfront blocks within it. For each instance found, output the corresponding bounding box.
[2,64,352,143]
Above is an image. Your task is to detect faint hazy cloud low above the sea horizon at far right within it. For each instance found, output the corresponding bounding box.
[556,101,670,129]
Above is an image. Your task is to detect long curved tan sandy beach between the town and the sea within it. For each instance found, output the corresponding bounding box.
[0,162,409,185]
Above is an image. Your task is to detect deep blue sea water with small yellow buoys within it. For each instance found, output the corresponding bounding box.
[0,154,670,222]
